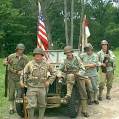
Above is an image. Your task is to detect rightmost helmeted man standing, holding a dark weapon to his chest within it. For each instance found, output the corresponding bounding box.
[97,40,115,100]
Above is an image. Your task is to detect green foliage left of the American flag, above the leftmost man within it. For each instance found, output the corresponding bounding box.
[0,0,37,56]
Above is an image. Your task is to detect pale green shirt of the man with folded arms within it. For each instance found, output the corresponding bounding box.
[80,53,98,77]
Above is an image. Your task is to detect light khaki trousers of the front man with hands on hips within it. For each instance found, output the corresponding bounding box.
[26,87,46,119]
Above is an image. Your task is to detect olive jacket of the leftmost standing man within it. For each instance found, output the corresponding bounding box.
[5,53,28,81]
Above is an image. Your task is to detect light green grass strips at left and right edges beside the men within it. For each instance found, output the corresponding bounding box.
[0,49,119,119]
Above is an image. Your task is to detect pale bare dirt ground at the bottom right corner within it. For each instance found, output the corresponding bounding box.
[77,84,119,119]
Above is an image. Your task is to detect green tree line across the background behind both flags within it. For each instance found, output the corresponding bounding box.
[0,0,119,56]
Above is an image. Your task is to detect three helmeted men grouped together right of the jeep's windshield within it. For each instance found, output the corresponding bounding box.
[60,40,115,117]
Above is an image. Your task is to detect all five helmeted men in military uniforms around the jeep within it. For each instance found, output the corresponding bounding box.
[4,40,115,119]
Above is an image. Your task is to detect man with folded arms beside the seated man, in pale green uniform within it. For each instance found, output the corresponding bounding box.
[81,43,99,104]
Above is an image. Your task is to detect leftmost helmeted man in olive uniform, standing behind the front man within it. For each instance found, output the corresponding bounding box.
[4,44,28,114]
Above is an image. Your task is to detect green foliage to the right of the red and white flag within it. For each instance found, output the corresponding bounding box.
[86,0,119,49]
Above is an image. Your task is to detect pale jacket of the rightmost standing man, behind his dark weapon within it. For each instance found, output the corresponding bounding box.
[97,50,115,72]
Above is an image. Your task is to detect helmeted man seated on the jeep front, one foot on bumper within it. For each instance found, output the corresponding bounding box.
[60,46,89,117]
